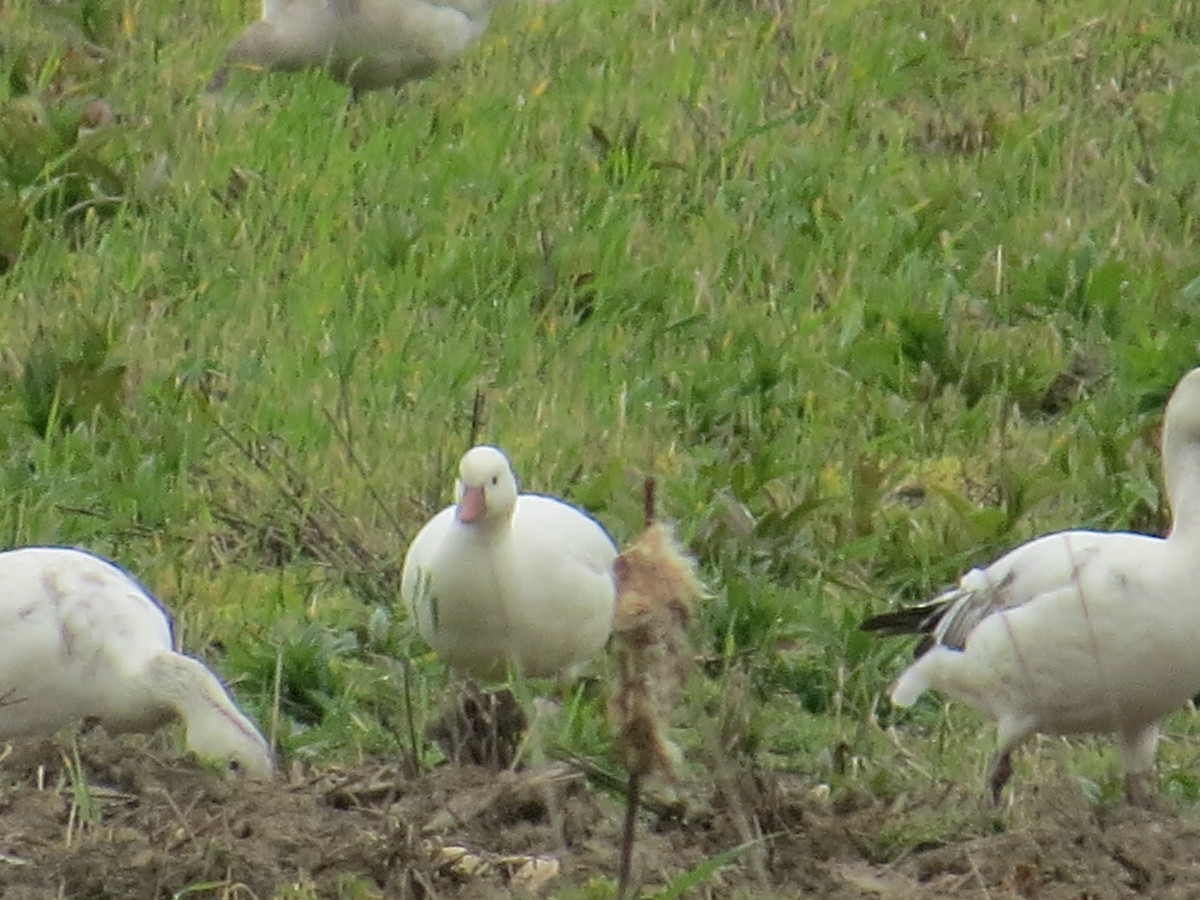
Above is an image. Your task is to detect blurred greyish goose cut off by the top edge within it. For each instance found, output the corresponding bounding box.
[210,0,498,96]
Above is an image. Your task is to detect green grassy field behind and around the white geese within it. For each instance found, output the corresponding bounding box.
[0,0,1200,897]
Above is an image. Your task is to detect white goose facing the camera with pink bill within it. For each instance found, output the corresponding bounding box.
[401,446,618,678]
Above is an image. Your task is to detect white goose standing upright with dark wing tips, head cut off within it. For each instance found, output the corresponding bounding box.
[863,368,1200,805]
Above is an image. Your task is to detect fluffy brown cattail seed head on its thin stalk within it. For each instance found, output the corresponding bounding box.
[608,478,703,900]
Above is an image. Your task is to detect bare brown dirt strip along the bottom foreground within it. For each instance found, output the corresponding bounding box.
[0,733,1200,900]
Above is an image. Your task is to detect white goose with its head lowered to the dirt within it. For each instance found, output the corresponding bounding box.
[0,547,274,778]
